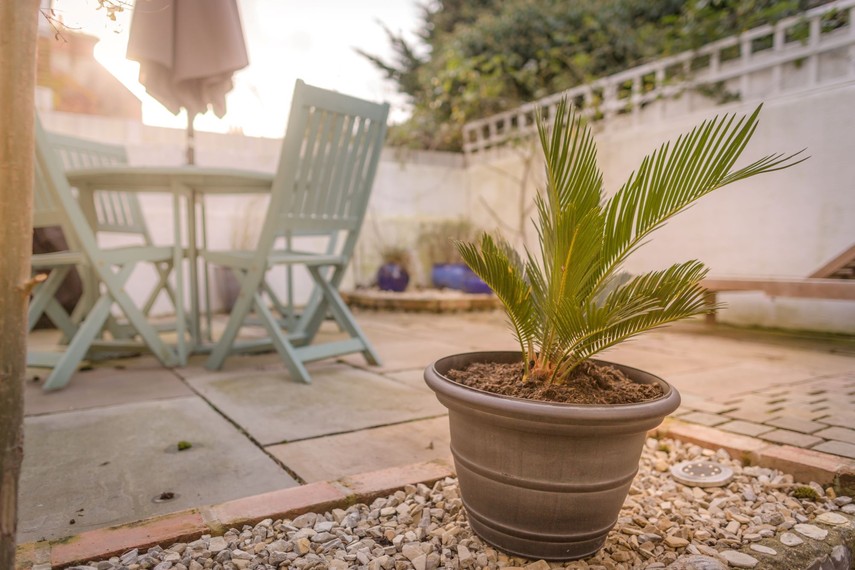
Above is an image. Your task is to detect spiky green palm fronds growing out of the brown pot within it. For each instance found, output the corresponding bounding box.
[457,97,803,382]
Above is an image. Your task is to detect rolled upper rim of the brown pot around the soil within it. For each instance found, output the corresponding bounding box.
[424,350,680,423]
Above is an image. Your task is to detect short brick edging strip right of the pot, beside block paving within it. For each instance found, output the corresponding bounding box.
[653,418,855,495]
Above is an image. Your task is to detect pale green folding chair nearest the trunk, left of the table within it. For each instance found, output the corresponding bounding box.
[27,120,186,390]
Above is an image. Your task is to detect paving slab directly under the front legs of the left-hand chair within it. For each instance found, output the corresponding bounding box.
[24,356,193,416]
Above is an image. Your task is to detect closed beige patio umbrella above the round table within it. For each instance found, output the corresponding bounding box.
[127,0,249,164]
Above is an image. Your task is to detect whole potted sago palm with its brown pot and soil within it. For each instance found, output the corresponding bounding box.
[425,101,799,560]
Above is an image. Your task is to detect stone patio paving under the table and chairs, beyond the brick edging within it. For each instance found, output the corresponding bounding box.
[18,311,855,542]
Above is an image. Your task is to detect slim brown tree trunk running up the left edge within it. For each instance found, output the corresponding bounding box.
[0,0,39,568]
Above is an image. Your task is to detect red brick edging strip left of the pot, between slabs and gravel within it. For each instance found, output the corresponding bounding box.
[15,459,454,570]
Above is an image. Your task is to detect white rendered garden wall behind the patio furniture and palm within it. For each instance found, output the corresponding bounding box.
[42,77,855,333]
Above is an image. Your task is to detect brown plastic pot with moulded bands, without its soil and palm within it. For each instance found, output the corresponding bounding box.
[425,352,680,560]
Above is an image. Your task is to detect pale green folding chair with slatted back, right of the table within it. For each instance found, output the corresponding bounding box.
[202,81,389,383]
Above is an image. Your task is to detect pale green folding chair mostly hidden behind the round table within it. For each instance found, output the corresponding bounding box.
[47,133,175,318]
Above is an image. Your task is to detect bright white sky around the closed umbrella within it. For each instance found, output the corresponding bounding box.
[46,0,422,138]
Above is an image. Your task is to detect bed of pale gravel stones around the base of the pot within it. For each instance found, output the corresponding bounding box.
[70,439,855,570]
